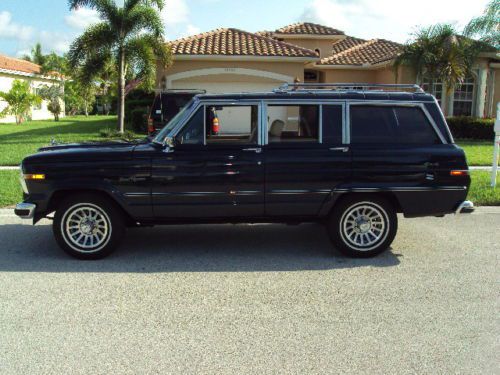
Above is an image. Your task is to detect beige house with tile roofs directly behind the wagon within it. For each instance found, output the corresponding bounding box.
[157,23,500,117]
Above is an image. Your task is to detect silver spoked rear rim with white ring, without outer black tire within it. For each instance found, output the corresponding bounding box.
[340,202,389,251]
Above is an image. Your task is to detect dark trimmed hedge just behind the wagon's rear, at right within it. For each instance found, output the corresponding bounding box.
[446,116,495,140]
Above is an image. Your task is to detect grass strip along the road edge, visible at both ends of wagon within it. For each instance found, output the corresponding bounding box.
[0,171,500,207]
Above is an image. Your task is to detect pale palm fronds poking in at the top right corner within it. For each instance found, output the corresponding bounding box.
[464,0,500,49]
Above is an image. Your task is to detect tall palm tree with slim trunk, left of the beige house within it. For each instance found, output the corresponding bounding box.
[68,0,170,133]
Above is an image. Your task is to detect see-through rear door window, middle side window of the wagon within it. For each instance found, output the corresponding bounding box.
[267,105,319,143]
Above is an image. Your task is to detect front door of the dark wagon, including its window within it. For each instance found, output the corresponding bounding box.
[152,101,264,219]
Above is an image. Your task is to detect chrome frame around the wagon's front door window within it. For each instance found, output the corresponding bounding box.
[171,99,263,146]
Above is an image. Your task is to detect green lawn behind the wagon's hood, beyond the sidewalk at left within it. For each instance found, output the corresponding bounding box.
[0,116,120,165]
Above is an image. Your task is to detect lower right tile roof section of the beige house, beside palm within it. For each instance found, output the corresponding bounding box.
[318,37,401,66]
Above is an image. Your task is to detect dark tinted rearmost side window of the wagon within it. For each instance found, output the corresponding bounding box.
[350,105,440,144]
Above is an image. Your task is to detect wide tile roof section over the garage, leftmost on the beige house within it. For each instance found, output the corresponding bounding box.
[170,28,316,58]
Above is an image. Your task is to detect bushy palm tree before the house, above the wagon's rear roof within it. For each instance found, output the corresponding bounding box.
[393,24,481,94]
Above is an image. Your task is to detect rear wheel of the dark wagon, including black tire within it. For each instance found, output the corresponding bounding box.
[327,194,398,258]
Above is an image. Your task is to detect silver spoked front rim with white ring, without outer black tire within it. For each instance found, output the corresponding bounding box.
[61,203,111,253]
